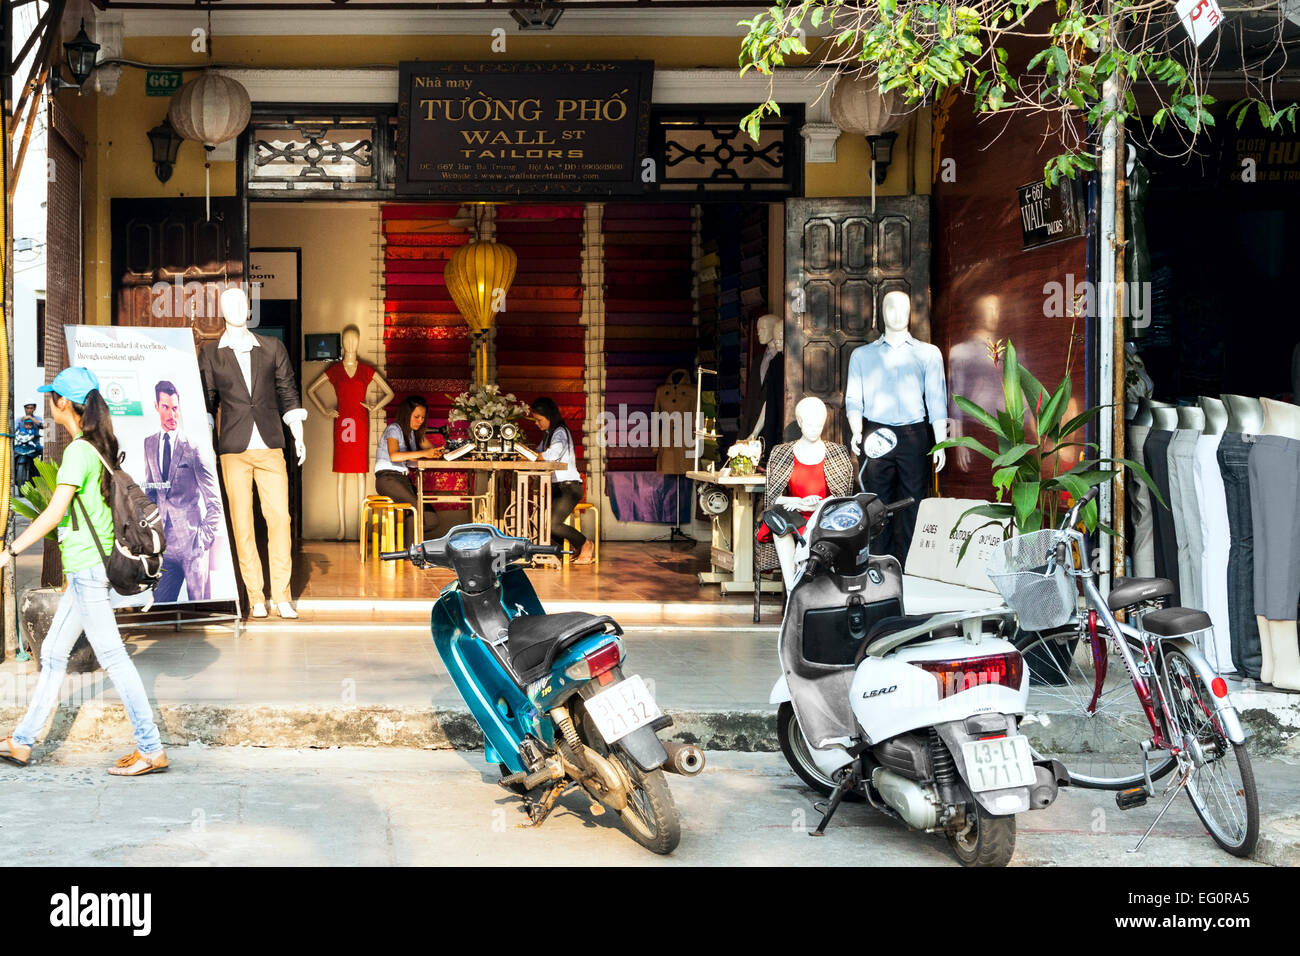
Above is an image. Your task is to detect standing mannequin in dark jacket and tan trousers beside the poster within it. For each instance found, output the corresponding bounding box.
[199,289,307,618]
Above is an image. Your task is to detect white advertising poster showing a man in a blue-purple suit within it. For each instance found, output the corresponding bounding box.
[66,325,238,605]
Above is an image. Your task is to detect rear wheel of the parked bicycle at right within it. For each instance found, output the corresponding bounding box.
[1165,650,1260,856]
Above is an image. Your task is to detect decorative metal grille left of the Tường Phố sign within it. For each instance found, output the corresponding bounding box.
[247,114,393,196]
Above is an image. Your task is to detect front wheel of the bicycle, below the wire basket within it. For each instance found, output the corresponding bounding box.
[1017,627,1177,790]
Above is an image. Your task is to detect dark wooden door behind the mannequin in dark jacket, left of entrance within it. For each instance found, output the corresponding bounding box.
[112,196,244,349]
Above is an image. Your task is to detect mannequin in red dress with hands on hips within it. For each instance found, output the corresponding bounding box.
[307,325,393,541]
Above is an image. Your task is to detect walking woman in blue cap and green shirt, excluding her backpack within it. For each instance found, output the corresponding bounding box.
[0,367,168,777]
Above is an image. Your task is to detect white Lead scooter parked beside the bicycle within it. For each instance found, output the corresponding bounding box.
[763,481,1069,866]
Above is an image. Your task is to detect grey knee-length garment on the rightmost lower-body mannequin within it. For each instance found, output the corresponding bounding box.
[1248,434,1300,620]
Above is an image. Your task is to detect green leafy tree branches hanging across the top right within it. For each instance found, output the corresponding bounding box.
[740,0,1297,185]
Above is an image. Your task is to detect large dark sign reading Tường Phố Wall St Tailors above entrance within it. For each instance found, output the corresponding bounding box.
[397,60,654,196]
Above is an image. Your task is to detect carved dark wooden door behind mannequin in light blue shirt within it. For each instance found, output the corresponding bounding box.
[785,196,930,444]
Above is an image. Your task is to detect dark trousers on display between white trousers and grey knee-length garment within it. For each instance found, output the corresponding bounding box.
[1218,432,1264,680]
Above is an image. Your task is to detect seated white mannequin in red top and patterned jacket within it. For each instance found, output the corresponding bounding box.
[758,397,853,592]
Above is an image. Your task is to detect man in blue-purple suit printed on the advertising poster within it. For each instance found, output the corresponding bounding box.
[144,378,221,604]
